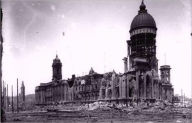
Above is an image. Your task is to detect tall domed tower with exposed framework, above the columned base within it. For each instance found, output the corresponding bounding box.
[127,1,158,71]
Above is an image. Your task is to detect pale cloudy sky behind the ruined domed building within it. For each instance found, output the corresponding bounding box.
[3,0,191,96]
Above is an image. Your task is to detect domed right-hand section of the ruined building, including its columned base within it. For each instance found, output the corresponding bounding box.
[100,1,173,104]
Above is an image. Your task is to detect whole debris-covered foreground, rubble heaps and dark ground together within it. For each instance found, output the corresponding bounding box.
[6,102,192,122]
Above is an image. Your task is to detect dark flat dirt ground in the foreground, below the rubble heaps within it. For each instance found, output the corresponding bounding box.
[3,107,192,123]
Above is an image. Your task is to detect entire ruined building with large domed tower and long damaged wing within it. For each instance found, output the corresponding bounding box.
[35,1,173,105]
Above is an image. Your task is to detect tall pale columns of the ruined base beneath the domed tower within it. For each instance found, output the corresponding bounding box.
[99,71,161,100]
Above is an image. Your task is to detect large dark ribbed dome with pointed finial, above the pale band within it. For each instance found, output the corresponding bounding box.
[130,1,156,31]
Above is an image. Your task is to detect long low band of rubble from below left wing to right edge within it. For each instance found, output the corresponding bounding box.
[33,101,192,117]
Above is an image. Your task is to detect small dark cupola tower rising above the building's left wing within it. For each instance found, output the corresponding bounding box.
[52,55,62,81]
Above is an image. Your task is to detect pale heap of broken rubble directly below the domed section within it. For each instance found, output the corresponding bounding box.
[78,101,173,113]
